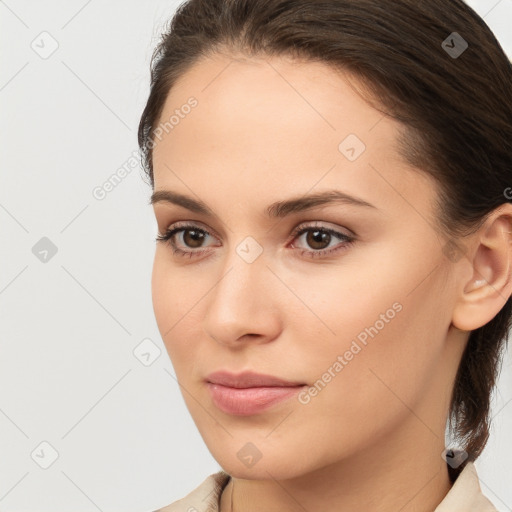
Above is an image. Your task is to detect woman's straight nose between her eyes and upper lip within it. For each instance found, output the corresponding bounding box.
[203,245,282,347]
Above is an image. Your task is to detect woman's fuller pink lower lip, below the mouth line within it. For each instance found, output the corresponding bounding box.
[207,382,305,416]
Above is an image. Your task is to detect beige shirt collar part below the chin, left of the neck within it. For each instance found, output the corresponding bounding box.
[154,470,231,512]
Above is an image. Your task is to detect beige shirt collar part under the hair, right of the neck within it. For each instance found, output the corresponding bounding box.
[434,462,498,512]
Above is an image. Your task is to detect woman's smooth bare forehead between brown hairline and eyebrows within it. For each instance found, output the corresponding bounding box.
[153,55,436,220]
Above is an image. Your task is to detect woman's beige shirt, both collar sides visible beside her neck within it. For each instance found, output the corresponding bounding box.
[155,462,498,512]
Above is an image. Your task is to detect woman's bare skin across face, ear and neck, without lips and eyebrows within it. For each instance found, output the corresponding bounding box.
[148,54,512,512]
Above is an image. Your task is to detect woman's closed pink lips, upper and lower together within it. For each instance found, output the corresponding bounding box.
[206,371,306,416]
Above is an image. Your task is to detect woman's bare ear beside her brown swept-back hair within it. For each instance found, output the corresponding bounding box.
[452,203,512,331]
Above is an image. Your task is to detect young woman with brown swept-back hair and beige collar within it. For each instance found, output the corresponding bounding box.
[139,0,512,512]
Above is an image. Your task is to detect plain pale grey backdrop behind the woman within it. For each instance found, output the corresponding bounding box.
[0,0,512,512]
